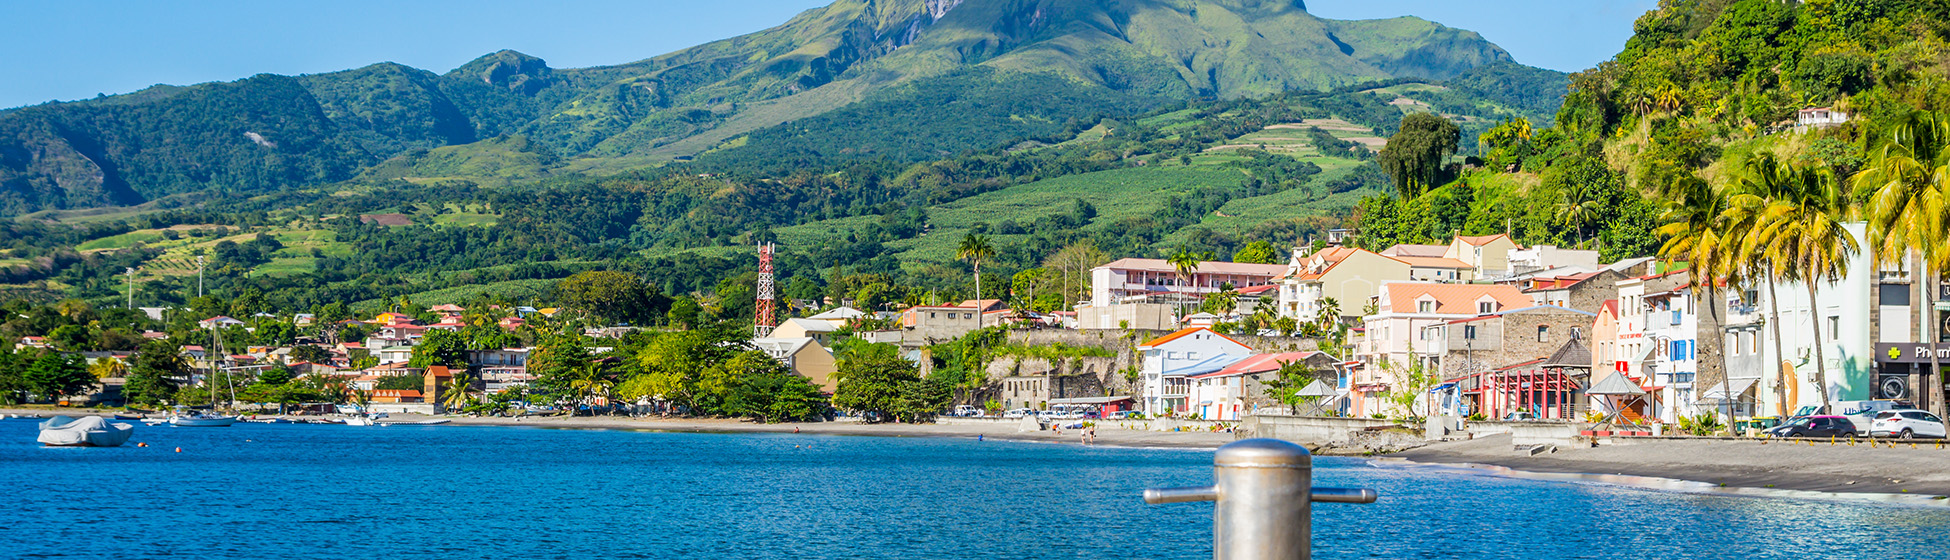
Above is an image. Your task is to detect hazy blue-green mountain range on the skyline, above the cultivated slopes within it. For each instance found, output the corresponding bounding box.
[0,0,1558,215]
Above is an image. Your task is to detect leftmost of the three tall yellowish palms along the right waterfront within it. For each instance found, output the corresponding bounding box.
[1658,178,1745,425]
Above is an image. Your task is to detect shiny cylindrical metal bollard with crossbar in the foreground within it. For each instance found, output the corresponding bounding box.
[1145,437,1377,560]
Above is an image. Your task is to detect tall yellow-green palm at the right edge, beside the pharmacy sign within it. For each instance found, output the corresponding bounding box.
[1853,111,1950,416]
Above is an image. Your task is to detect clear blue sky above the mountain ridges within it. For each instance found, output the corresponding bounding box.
[0,0,1656,107]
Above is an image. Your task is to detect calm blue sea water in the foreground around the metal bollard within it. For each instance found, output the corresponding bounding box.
[0,420,1950,560]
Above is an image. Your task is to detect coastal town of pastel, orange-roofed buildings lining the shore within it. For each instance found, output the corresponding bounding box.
[14,213,1950,442]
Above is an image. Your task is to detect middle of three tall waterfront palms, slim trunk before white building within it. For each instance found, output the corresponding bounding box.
[1757,164,1860,410]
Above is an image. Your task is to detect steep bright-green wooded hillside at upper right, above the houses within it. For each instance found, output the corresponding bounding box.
[1361,0,1950,258]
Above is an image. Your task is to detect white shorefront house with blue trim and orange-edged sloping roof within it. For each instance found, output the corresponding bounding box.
[1137,326,1254,416]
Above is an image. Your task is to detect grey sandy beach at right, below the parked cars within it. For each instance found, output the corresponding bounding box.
[1388,435,1950,496]
